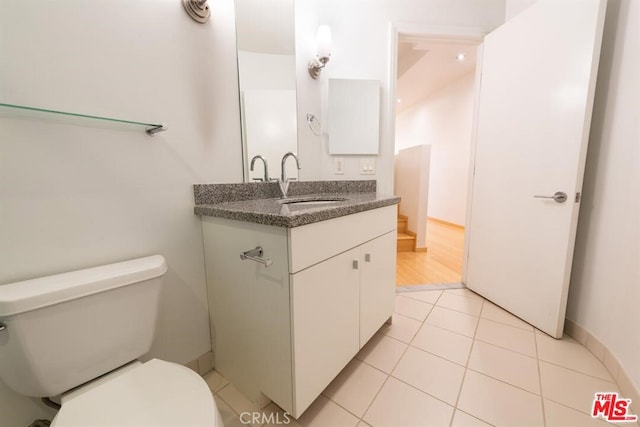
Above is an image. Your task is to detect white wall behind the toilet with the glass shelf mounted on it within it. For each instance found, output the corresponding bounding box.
[0,0,242,426]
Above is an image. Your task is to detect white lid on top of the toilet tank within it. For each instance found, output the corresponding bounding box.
[0,255,167,318]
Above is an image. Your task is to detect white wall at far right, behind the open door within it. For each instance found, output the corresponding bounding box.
[567,0,640,396]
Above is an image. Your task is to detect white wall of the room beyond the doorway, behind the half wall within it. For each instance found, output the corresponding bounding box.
[396,73,475,225]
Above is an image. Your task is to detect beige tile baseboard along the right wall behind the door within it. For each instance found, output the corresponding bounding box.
[564,319,640,415]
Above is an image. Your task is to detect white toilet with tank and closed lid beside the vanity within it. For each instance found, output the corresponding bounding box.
[0,255,223,427]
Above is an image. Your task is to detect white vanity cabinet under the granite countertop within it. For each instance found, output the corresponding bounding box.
[202,206,396,418]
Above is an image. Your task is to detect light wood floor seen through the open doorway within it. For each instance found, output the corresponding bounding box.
[396,219,464,286]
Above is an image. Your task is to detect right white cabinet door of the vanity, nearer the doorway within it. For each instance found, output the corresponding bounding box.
[360,231,396,348]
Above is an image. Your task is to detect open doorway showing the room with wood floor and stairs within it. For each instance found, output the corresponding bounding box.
[392,29,483,287]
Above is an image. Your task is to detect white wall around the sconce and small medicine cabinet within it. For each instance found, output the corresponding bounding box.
[296,0,504,193]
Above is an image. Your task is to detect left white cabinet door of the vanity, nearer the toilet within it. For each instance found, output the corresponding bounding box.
[291,248,360,417]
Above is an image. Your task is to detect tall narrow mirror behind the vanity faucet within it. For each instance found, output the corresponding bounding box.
[235,0,298,182]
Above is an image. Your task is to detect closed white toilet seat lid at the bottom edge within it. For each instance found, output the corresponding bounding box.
[52,359,222,427]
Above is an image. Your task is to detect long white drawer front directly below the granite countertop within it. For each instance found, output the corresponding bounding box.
[289,205,397,273]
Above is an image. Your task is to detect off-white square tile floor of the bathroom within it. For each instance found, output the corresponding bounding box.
[205,289,635,427]
